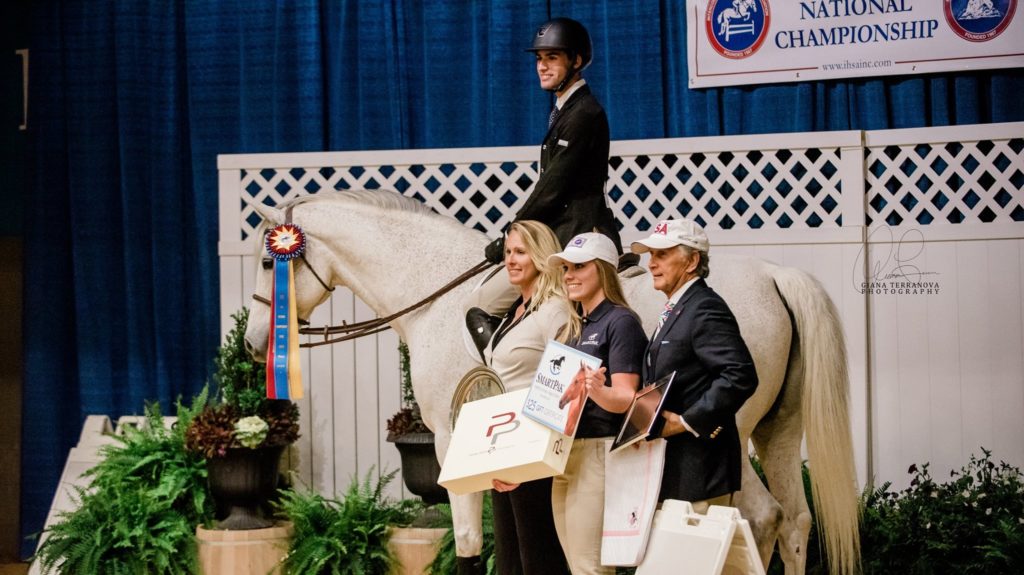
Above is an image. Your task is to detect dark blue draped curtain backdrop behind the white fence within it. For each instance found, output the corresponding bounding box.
[22,0,1024,552]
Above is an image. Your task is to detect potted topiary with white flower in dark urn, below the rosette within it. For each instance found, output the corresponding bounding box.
[185,309,299,529]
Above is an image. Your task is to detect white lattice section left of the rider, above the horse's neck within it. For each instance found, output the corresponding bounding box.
[234,160,537,239]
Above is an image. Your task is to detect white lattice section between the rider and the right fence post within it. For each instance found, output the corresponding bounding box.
[608,147,843,231]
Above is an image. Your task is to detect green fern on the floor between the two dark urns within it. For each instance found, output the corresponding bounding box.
[279,469,422,575]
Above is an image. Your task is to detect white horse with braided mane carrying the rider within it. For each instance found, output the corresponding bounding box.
[246,190,859,575]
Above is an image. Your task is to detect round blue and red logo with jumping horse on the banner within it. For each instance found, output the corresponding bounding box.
[705,0,771,59]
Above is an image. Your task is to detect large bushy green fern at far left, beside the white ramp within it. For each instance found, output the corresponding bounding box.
[36,390,213,575]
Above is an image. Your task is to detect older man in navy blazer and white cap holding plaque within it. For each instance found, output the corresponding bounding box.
[631,219,758,513]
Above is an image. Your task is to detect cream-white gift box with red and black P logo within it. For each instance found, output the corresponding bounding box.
[437,388,572,495]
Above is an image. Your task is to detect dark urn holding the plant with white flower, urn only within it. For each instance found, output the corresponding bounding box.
[206,445,285,531]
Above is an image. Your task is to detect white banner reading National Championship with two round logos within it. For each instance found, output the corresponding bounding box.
[686,0,1024,88]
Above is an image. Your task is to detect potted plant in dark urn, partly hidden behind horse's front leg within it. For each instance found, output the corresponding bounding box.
[387,342,449,504]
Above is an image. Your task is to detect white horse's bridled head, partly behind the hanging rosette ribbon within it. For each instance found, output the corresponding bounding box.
[246,205,336,361]
